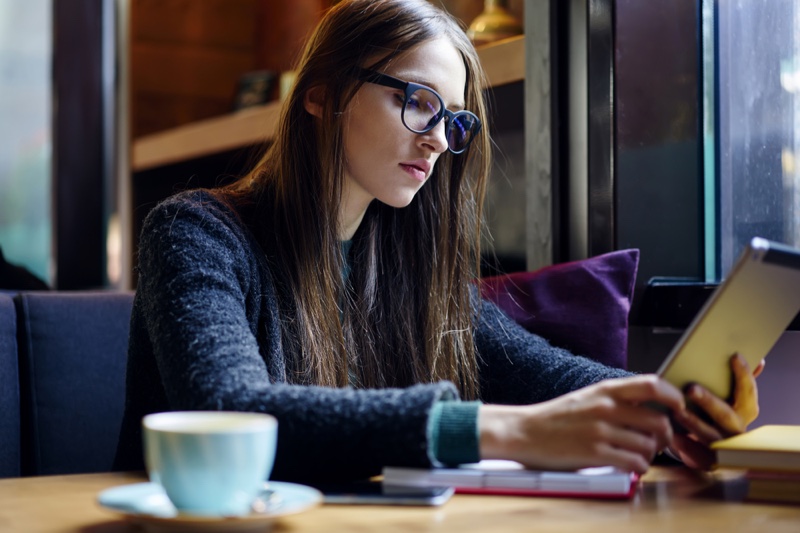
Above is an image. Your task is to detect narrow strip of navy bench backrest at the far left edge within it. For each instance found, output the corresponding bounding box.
[0,292,20,477]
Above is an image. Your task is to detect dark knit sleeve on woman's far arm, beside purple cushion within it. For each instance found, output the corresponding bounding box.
[474,290,632,405]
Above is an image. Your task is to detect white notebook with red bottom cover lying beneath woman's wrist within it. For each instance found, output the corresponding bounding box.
[383,460,638,499]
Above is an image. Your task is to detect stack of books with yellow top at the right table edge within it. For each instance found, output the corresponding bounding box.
[711,425,800,503]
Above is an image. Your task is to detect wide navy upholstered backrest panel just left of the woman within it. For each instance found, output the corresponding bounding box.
[14,291,133,475]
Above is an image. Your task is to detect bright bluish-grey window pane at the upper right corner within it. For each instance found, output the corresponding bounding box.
[703,0,800,275]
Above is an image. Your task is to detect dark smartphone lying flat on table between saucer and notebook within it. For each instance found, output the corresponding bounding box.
[312,481,454,506]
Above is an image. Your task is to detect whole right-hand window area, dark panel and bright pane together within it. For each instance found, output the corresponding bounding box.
[616,0,800,283]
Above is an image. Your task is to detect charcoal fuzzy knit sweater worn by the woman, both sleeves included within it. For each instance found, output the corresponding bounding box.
[115,191,627,481]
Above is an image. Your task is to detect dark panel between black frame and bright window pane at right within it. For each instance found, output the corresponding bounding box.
[615,0,703,284]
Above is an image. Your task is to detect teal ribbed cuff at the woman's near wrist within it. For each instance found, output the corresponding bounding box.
[428,400,481,465]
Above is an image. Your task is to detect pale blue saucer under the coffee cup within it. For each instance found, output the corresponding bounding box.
[97,481,322,531]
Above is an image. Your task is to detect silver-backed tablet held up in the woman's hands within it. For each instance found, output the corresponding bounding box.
[658,237,800,399]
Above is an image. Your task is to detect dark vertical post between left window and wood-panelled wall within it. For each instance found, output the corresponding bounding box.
[53,0,113,290]
